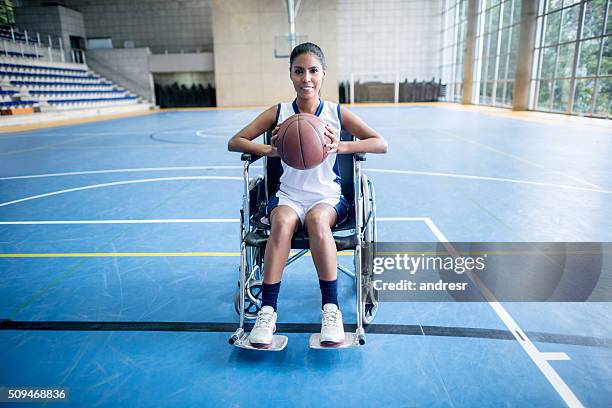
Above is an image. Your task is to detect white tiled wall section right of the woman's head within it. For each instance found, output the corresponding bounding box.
[337,0,442,80]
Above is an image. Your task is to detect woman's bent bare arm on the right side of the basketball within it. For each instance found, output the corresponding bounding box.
[338,106,389,154]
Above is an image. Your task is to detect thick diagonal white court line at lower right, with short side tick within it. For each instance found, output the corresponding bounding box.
[425,218,583,407]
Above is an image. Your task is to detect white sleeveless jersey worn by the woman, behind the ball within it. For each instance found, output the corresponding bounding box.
[276,100,342,200]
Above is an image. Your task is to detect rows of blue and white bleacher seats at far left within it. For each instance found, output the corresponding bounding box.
[0,53,140,115]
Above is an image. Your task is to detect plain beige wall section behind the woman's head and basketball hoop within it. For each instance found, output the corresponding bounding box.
[212,0,338,106]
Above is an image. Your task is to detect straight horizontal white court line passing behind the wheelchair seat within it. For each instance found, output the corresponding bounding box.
[0,217,426,225]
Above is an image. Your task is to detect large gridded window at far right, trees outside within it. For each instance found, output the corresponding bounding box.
[531,0,612,117]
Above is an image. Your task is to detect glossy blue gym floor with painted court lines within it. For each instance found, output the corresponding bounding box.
[0,106,612,407]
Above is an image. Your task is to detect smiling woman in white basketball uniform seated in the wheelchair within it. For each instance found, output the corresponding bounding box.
[228,43,387,346]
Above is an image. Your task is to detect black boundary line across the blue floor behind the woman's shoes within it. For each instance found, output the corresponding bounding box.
[0,319,612,348]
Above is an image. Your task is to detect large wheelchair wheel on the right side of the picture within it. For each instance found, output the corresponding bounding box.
[361,174,378,324]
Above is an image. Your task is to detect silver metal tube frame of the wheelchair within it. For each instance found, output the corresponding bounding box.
[229,131,378,348]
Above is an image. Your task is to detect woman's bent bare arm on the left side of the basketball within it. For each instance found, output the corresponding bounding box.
[227,105,278,157]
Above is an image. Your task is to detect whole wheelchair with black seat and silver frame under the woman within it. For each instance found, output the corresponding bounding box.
[229,130,378,351]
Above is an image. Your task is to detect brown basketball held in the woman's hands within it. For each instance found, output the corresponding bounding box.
[274,113,331,170]
